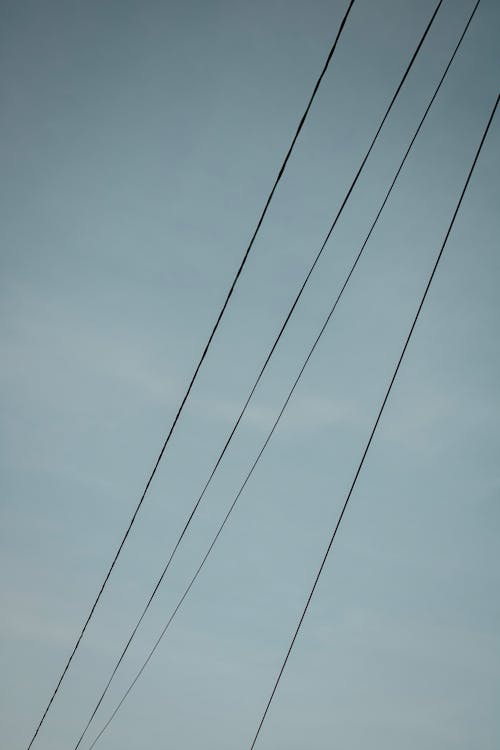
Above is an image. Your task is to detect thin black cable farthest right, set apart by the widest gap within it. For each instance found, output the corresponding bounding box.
[250,97,500,750]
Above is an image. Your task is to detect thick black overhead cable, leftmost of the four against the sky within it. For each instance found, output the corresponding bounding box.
[27,0,355,750]
